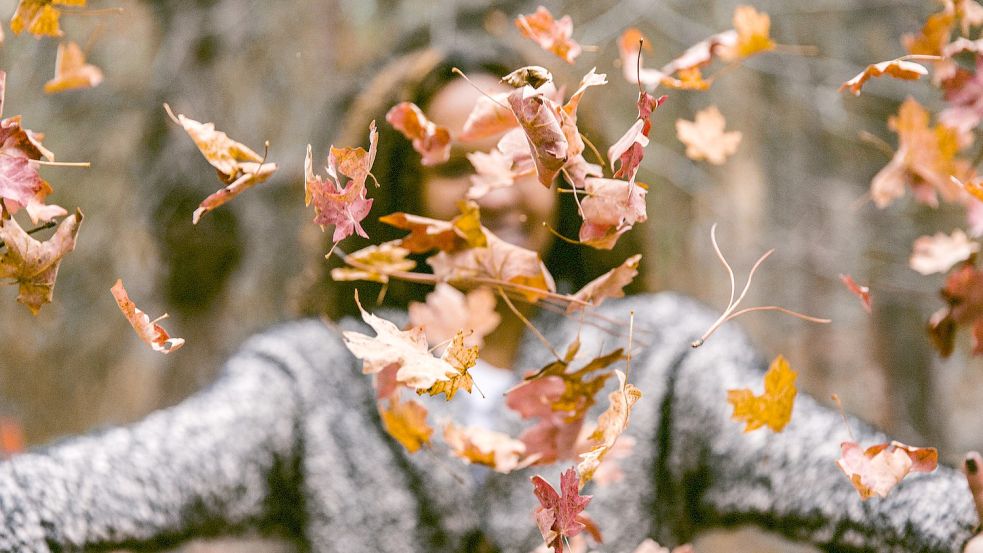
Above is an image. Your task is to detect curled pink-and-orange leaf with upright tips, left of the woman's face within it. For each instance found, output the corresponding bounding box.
[304,121,379,243]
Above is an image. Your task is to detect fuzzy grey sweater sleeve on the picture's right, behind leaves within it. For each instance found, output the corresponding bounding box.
[657,292,977,552]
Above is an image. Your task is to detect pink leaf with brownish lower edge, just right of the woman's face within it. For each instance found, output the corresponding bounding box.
[579,177,648,250]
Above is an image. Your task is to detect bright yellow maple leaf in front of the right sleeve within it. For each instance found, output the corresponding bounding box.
[727,355,798,432]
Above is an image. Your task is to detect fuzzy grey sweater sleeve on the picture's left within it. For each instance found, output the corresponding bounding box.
[0,338,298,552]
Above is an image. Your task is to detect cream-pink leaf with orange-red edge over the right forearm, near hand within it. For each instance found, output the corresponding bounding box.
[836,442,939,500]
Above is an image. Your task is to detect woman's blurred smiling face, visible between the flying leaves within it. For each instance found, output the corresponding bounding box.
[423,74,556,253]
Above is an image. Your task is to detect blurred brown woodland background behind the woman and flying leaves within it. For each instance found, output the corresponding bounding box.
[0,0,983,553]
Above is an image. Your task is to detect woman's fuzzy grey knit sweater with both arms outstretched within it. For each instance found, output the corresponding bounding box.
[0,294,976,553]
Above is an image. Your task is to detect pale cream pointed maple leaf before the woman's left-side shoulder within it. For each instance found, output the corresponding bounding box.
[342,292,460,390]
